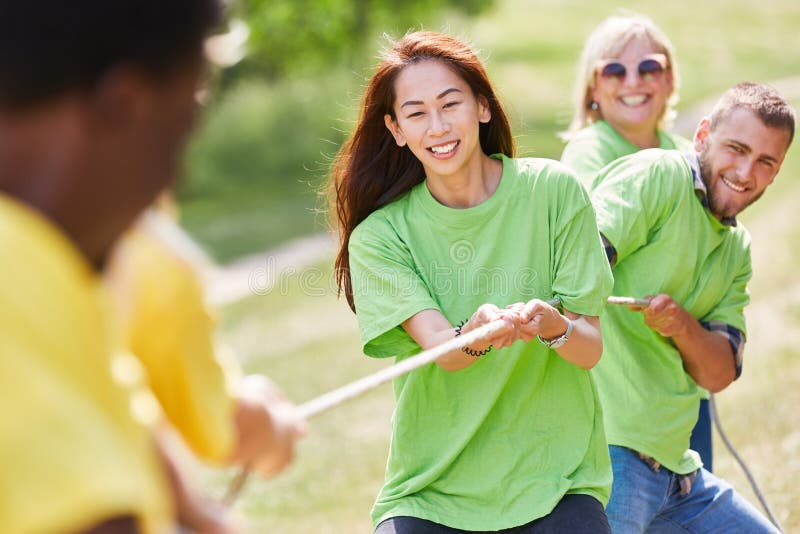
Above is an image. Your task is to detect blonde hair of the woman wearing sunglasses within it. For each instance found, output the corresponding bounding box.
[561,14,680,140]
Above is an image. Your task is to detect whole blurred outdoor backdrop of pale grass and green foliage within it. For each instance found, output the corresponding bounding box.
[179,0,800,533]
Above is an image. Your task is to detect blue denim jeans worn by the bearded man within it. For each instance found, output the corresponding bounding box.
[606,445,778,534]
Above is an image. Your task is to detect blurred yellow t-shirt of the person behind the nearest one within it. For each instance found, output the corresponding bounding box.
[107,220,239,461]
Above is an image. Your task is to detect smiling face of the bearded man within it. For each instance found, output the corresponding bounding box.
[695,108,790,219]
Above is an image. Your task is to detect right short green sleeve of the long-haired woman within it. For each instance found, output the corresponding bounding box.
[552,169,613,315]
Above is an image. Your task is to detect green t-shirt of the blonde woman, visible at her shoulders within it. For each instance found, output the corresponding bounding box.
[561,120,692,188]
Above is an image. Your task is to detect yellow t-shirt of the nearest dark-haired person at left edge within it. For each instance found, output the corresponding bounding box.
[0,195,172,534]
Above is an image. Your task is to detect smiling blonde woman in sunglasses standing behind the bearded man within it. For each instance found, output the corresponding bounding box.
[561,15,690,187]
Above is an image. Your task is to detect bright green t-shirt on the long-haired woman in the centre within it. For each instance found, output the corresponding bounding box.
[349,156,612,530]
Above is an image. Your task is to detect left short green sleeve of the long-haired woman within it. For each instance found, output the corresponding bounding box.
[348,212,439,357]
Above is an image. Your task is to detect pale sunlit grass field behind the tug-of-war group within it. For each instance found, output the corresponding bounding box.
[190,0,800,533]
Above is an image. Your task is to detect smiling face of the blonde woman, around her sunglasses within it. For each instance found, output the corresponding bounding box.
[592,38,672,143]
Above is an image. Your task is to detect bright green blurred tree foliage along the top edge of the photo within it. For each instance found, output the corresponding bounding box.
[223,0,493,81]
